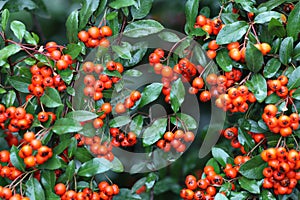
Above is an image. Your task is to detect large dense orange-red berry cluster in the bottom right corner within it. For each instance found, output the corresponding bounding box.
[261,147,300,195]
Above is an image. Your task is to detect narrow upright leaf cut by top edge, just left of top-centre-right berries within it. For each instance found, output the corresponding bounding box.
[185,0,199,31]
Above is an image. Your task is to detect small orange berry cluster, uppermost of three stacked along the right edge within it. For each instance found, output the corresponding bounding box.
[267,75,296,99]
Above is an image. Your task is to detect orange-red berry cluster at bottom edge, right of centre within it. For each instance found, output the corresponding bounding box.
[180,165,224,200]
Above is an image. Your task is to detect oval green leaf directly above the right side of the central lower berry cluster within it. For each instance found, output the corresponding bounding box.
[171,113,198,130]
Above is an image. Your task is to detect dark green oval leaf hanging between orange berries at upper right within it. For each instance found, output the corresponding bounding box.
[246,42,264,72]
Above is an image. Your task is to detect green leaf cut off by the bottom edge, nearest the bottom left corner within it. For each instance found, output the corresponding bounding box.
[26,177,45,200]
